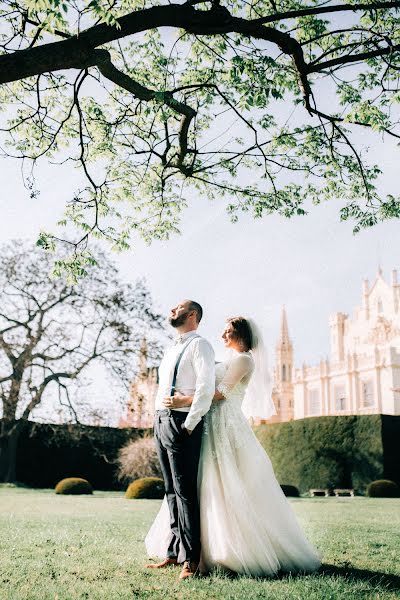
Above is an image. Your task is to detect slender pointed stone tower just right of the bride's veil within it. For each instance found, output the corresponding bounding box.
[270,307,294,423]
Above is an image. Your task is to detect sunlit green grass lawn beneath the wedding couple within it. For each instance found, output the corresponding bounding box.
[0,487,400,600]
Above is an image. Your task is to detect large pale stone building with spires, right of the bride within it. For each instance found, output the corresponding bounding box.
[271,269,400,422]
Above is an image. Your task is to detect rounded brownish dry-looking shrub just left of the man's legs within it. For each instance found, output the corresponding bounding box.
[117,437,161,482]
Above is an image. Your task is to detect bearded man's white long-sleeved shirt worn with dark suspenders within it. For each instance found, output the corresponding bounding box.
[155,331,215,431]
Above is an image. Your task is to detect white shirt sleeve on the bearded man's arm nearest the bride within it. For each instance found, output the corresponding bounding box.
[184,338,215,431]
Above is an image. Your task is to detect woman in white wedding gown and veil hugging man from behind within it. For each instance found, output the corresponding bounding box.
[145,317,320,577]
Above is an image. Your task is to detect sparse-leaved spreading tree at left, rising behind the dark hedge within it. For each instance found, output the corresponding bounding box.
[0,242,162,481]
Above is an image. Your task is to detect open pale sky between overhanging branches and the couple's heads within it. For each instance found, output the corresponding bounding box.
[0,145,400,366]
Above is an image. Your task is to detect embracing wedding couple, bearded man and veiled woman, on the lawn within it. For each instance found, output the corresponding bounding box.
[145,300,320,580]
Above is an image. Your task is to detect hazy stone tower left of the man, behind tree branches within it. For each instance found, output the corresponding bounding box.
[118,339,158,429]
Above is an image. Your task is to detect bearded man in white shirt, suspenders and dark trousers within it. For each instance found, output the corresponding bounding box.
[147,300,215,579]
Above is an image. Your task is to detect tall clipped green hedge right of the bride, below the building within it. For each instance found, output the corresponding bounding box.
[255,415,400,494]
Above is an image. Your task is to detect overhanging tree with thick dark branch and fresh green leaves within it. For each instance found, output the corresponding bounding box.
[0,0,400,271]
